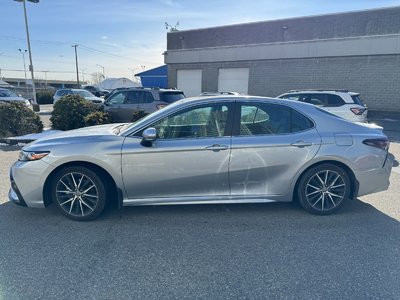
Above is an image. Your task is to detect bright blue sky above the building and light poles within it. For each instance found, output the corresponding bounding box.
[0,0,400,80]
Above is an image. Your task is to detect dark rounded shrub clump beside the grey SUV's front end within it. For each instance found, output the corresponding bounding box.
[50,95,111,130]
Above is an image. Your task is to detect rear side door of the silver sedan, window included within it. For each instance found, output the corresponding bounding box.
[230,101,321,197]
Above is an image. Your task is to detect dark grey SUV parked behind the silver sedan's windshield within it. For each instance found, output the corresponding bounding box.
[103,88,185,122]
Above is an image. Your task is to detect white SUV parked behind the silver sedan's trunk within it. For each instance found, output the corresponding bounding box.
[278,90,368,122]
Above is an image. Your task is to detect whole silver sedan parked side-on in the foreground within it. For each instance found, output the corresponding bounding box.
[9,95,392,220]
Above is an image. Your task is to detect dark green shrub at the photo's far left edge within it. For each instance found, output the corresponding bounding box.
[0,102,43,138]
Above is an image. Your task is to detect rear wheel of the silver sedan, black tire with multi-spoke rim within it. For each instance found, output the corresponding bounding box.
[297,163,351,215]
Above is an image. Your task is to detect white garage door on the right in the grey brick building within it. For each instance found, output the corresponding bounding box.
[218,68,249,94]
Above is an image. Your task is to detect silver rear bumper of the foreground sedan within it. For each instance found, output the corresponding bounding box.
[356,153,394,196]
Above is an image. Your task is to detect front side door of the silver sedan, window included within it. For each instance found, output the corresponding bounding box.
[122,103,232,201]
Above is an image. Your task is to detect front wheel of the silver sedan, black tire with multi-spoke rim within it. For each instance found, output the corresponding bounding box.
[51,166,106,221]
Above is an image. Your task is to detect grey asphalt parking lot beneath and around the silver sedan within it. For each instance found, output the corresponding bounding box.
[0,109,400,299]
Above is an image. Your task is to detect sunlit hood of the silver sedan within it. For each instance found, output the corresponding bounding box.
[26,123,126,148]
